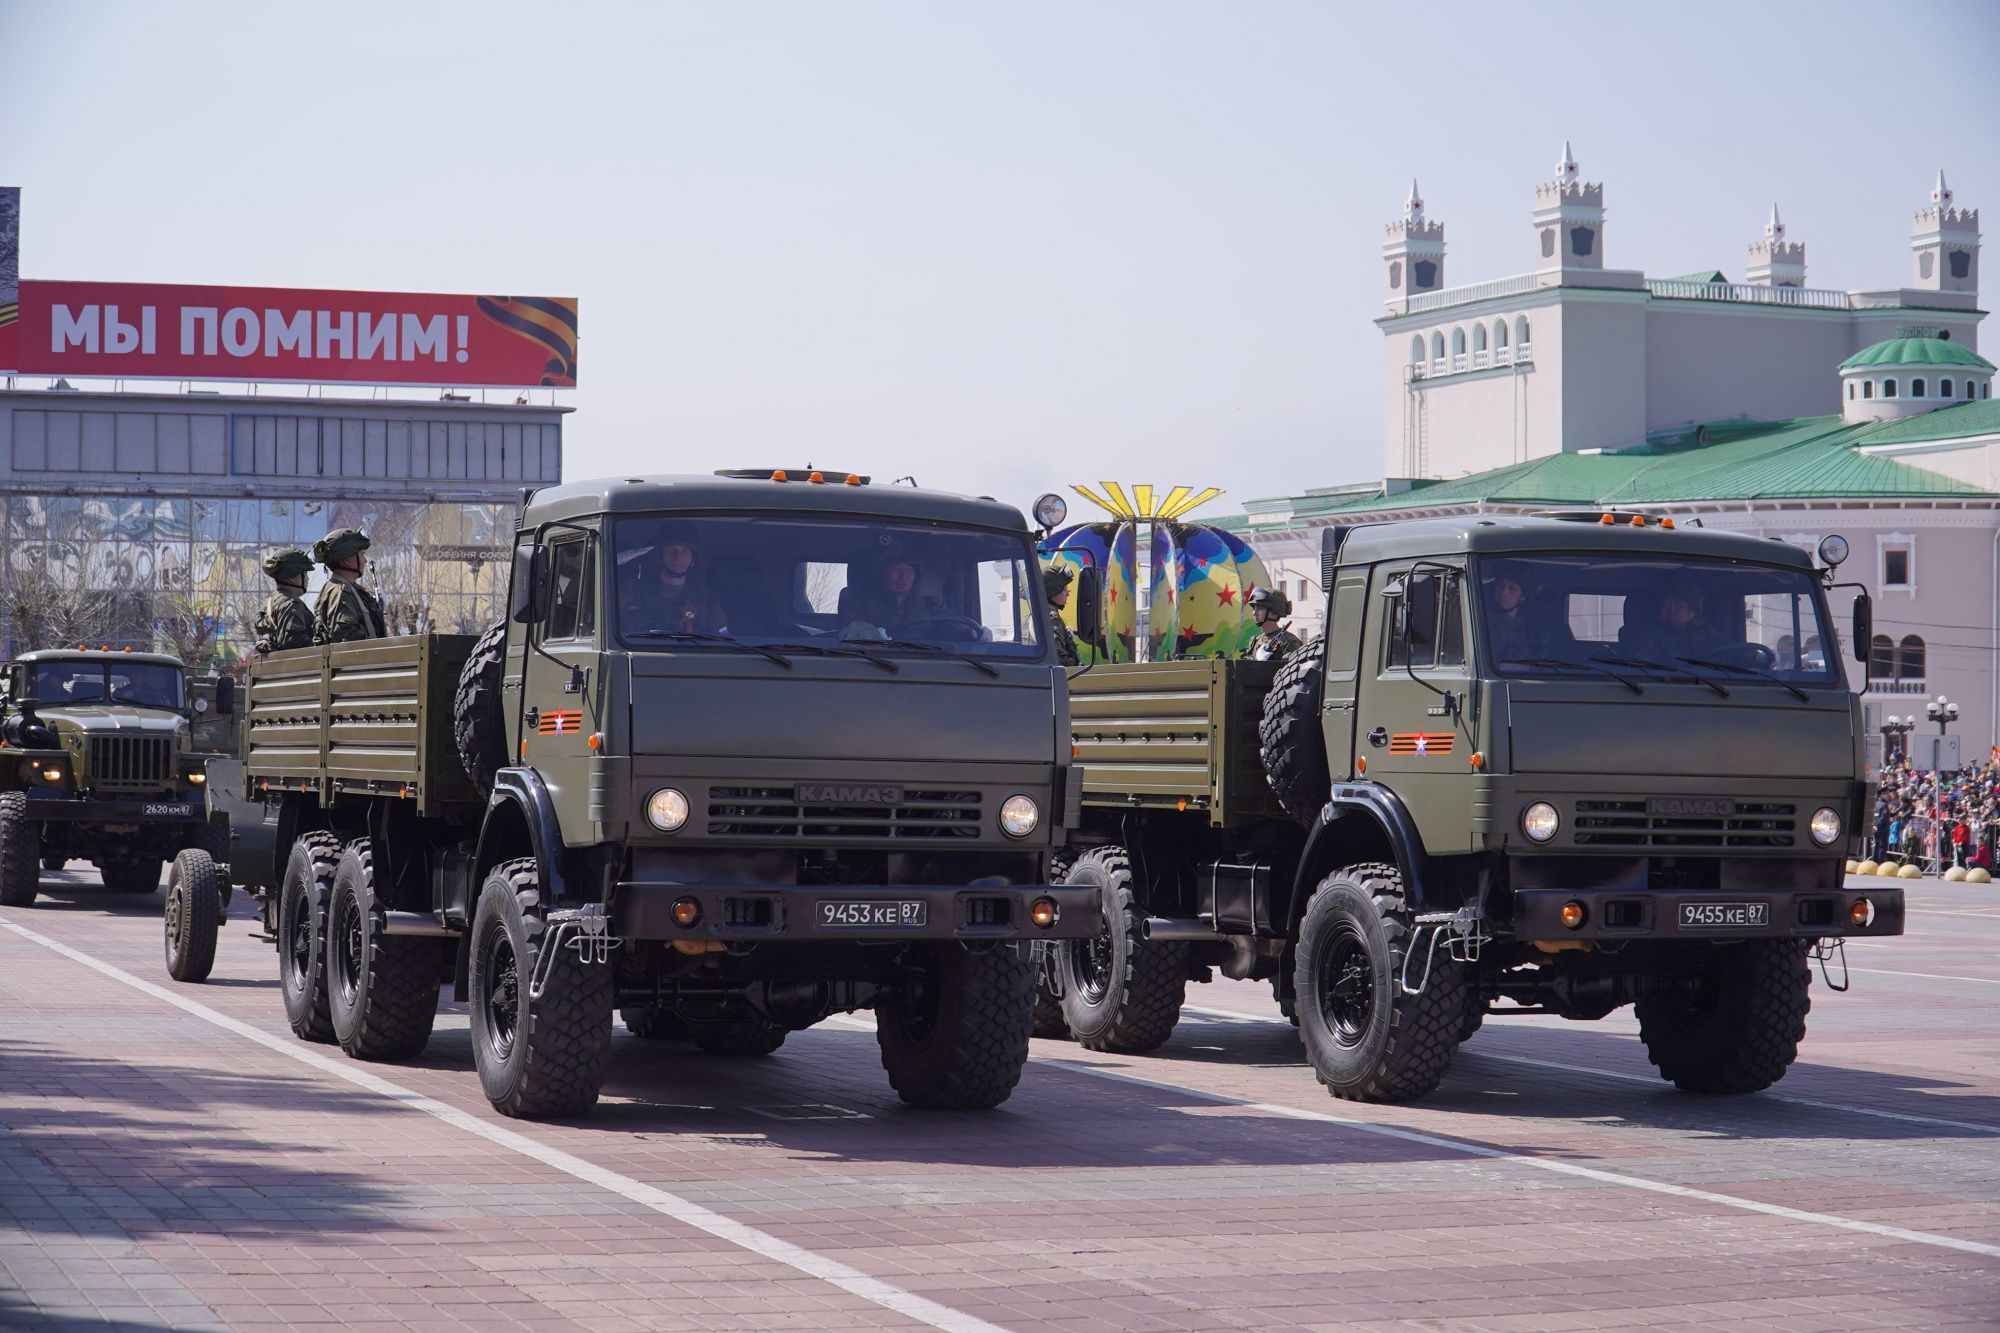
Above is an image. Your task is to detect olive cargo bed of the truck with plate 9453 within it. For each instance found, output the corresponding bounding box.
[244,634,478,815]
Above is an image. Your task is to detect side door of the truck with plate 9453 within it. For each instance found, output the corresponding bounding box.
[520,528,604,843]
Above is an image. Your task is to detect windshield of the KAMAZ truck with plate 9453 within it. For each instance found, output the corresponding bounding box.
[612,516,1046,658]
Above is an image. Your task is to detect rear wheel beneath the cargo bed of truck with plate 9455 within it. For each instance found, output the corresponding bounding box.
[1056,847,1188,1055]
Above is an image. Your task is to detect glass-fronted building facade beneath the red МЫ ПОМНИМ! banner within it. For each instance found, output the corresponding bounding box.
[0,384,570,660]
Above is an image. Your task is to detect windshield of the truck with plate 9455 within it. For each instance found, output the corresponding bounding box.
[1478,554,1840,687]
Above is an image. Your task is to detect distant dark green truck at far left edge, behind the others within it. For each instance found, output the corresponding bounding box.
[0,648,234,907]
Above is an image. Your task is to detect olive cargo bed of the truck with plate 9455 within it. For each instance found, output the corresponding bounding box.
[1070,658,1284,825]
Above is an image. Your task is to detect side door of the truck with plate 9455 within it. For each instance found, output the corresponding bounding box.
[1356,560,1476,855]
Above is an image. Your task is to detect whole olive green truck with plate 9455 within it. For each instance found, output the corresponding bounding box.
[1036,512,1904,1101]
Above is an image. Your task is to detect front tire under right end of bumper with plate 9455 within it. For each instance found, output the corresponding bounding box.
[1634,939,1812,1093]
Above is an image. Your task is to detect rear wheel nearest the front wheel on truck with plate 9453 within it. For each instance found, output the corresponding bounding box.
[322,839,440,1061]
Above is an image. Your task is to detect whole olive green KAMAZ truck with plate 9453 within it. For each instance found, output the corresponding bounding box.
[230,470,1098,1117]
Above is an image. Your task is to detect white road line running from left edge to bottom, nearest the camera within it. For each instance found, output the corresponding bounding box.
[0,921,1002,1333]
